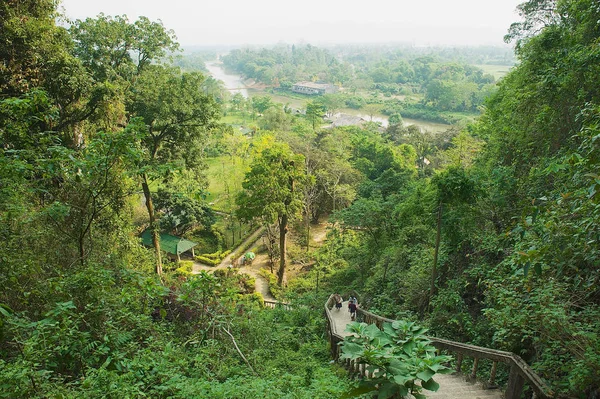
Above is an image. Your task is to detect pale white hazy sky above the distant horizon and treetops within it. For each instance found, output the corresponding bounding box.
[58,0,525,46]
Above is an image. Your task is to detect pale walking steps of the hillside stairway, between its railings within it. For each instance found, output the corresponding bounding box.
[331,301,504,399]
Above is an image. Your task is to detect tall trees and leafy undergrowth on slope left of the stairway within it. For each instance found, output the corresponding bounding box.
[0,0,349,399]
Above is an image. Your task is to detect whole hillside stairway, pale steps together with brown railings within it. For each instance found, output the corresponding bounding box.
[325,295,554,399]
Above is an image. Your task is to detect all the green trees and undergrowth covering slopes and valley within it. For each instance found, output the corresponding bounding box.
[0,0,600,399]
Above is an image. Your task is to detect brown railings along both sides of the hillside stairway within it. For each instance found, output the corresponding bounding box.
[325,295,554,399]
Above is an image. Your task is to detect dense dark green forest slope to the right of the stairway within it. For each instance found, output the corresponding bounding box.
[324,0,600,397]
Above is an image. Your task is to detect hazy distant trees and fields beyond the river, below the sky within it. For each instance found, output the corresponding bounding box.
[216,45,511,124]
